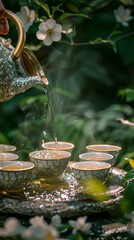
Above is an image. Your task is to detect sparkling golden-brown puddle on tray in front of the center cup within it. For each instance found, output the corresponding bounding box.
[24,173,83,202]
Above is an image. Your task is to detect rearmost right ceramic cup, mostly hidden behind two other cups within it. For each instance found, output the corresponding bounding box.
[86,144,121,166]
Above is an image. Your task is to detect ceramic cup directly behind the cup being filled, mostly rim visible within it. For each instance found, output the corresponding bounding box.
[42,141,74,152]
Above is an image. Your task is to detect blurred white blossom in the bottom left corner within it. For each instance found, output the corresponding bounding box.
[0,218,26,237]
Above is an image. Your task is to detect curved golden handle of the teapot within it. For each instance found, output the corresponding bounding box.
[5,9,26,61]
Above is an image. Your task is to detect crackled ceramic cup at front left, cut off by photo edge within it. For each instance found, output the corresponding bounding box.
[0,161,34,192]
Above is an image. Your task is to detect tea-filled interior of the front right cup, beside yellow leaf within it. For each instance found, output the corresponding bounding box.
[71,161,111,171]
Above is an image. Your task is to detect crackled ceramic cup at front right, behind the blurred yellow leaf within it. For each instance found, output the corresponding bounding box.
[71,161,111,183]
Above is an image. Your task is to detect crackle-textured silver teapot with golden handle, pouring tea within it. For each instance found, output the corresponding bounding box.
[0,10,48,102]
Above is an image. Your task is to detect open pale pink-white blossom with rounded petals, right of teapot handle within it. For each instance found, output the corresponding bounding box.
[36,19,62,46]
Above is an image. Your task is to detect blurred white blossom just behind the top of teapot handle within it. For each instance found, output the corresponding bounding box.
[16,6,35,32]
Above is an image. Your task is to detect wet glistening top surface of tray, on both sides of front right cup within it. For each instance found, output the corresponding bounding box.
[0,168,124,203]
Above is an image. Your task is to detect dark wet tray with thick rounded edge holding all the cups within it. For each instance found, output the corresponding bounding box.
[0,168,126,218]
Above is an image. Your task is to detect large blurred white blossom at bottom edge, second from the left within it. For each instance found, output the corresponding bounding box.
[22,216,59,240]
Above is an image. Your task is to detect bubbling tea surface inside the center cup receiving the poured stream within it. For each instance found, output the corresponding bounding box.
[29,150,71,160]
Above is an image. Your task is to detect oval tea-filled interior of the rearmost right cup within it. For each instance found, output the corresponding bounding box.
[86,144,121,152]
